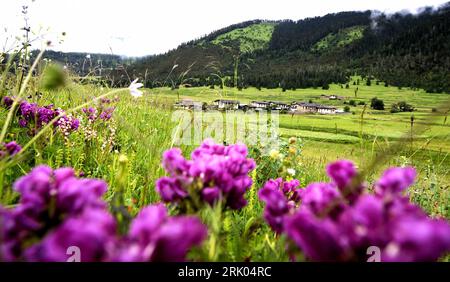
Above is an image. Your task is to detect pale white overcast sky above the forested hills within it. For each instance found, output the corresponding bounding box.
[0,0,446,56]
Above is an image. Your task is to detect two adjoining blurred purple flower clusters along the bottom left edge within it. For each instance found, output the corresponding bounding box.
[0,166,207,262]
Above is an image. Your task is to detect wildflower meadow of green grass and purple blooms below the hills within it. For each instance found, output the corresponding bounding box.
[0,1,450,262]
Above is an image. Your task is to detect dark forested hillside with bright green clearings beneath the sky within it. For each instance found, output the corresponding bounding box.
[40,3,450,93]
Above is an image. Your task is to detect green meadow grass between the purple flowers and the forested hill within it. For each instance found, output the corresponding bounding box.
[0,69,450,261]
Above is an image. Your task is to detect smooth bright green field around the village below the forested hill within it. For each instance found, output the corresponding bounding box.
[147,77,450,187]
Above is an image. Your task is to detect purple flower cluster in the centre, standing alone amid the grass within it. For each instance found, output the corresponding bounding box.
[156,139,255,209]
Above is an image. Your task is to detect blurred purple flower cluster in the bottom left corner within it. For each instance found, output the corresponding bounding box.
[0,166,107,260]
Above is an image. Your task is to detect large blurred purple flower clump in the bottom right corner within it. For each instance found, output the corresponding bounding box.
[274,161,450,261]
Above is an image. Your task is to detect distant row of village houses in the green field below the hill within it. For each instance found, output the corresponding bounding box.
[174,95,344,115]
